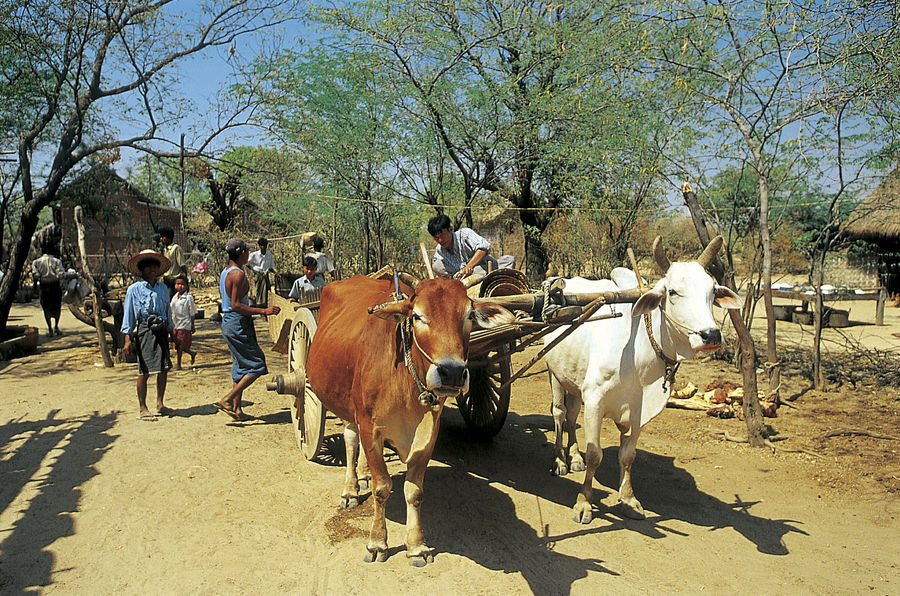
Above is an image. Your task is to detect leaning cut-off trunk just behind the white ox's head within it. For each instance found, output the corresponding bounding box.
[681,182,771,447]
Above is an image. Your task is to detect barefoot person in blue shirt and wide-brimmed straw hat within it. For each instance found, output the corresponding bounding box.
[122,249,175,422]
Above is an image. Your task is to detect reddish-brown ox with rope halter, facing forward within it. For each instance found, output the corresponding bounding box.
[306,276,512,566]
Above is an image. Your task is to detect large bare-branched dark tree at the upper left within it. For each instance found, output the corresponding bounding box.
[0,0,293,330]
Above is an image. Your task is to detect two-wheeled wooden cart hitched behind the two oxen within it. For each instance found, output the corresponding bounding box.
[266,270,642,460]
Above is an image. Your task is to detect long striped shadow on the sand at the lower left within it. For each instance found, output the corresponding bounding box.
[0,410,118,594]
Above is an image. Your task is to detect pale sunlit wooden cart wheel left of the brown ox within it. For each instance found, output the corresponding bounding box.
[287,308,325,460]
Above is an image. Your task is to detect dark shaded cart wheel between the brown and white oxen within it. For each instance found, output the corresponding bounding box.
[456,345,510,439]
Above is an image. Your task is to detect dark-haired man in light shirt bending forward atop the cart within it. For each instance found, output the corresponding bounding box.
[428,214,497,279]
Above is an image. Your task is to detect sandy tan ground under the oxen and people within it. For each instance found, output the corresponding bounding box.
[0,302,900,594]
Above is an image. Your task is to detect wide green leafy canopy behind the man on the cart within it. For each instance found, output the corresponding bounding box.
[246,1,670,280]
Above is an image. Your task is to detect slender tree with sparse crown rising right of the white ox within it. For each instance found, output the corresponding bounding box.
[656,0,896,394]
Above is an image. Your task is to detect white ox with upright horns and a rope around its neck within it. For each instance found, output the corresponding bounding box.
[545,236,741,524]
